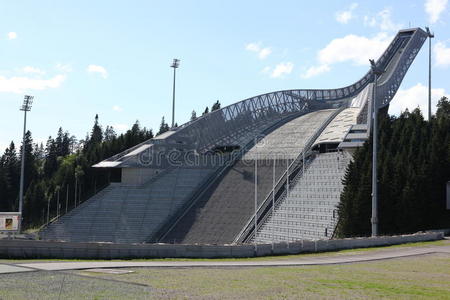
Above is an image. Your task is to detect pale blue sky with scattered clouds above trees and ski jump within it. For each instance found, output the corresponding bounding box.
[0,0,450,153]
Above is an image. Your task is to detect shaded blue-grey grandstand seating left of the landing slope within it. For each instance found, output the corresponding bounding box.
[41,168,213,243]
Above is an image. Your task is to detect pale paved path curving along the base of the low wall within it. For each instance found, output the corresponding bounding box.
[0,241,450,273]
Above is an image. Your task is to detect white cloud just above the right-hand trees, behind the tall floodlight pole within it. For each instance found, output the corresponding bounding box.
[389,83,449,118]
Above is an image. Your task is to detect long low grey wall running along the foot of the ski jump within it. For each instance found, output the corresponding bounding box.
[0,232,444,259]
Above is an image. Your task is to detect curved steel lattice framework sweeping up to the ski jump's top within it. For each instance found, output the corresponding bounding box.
[97,28,427,167]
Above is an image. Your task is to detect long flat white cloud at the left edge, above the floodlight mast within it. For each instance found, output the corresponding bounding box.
[0,75,66,94]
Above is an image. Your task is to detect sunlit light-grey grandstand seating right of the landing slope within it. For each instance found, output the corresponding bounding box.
[257,152,350,242]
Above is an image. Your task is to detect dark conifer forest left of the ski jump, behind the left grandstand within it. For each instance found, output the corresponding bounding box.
[0,101,220,229]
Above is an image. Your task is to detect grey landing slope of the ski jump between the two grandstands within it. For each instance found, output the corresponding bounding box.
[162,110,334,244]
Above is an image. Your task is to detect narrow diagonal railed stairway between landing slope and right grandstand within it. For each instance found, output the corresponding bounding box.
[233,106,347,243]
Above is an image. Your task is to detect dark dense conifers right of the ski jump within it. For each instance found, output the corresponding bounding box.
[337,97,450,237]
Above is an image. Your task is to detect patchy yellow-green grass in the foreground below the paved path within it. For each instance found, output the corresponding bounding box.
[73,254,450,299]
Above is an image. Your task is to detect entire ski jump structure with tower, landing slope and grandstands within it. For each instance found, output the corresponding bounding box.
[41,28,427,244]
